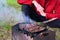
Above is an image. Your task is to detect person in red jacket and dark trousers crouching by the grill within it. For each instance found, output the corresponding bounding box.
[17,0,60,28]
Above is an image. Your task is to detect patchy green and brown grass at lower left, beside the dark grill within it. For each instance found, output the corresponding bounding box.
[0,23,12,40]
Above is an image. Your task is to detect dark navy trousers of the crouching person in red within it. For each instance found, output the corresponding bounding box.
[22,5,60,28]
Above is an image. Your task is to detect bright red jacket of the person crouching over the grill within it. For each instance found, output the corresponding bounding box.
[17,0,60,19]
